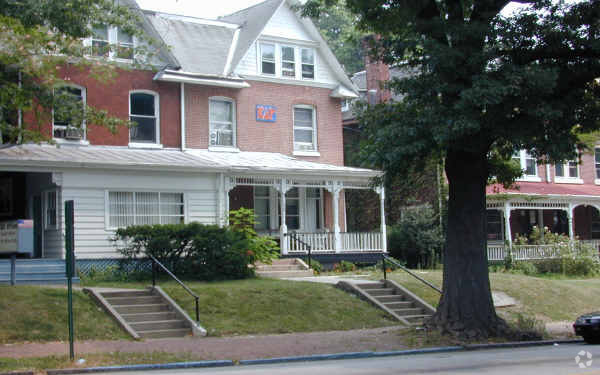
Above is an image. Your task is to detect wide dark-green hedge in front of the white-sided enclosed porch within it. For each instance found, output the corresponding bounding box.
[114,223,256,280]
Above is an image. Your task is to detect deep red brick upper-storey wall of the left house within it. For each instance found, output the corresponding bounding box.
[33,66,181,147]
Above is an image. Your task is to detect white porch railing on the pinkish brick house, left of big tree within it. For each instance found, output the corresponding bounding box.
[285,232,383,253]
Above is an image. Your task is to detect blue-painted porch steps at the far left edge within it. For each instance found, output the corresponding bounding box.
[0,259,79,285]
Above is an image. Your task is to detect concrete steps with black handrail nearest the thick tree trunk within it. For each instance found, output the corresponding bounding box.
[337,280,435,326]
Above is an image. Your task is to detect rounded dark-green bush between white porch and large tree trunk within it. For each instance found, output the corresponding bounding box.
[388,206,444,268]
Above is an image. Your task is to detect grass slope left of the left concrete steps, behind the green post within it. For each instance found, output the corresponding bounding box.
[0,286,128,344]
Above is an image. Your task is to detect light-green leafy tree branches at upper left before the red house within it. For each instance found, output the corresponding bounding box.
[0,0,153,143]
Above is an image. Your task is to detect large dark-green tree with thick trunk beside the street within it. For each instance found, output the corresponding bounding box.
[305,0,600,338]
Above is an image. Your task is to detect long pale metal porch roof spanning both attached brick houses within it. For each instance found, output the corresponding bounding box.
[0,144,380,179]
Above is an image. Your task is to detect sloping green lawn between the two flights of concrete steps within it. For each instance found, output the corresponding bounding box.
[163,279,397,336]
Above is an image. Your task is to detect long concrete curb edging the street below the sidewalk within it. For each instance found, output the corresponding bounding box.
[38,340,584,375]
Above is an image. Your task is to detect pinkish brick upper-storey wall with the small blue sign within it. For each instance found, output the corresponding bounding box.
[185,81,344,165]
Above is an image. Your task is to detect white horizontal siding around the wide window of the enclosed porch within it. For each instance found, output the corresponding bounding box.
[61,172,217,259]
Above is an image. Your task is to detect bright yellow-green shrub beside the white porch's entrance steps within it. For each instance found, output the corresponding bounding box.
[229,207,281,264]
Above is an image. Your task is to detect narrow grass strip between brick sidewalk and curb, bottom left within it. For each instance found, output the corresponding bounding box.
[0,352,202,372]
